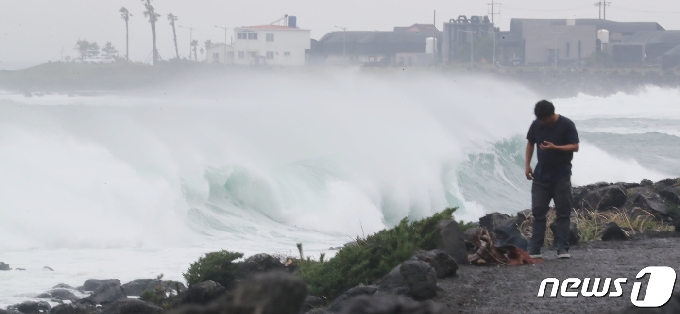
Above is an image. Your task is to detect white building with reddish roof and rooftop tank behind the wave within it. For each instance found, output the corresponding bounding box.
[234,16,311,66]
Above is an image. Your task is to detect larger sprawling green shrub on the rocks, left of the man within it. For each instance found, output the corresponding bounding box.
[299,208,457,300]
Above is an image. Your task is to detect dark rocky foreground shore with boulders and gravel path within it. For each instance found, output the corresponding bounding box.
[0,179,680,314]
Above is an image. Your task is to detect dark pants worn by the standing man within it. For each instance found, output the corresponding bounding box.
[529,177,572,254]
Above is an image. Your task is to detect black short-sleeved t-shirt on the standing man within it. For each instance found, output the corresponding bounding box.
[527,116,579,181]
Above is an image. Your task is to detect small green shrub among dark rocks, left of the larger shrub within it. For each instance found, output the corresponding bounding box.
[182,250,243,287]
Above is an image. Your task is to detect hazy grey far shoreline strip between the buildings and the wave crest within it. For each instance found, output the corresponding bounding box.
[0,62,680,98]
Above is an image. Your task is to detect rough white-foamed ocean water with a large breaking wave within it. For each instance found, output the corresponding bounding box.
[0,70,680,308]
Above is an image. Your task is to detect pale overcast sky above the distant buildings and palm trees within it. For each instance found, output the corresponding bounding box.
[0,0,680,65]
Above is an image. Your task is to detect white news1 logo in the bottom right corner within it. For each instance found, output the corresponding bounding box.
[538,266,676,307]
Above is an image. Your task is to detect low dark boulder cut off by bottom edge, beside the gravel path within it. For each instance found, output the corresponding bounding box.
[340,295,444,314]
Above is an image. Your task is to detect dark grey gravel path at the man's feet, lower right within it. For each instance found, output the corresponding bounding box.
[434,233,680,314]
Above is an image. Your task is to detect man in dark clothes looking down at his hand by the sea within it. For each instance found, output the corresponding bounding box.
[525,100,579,258]
